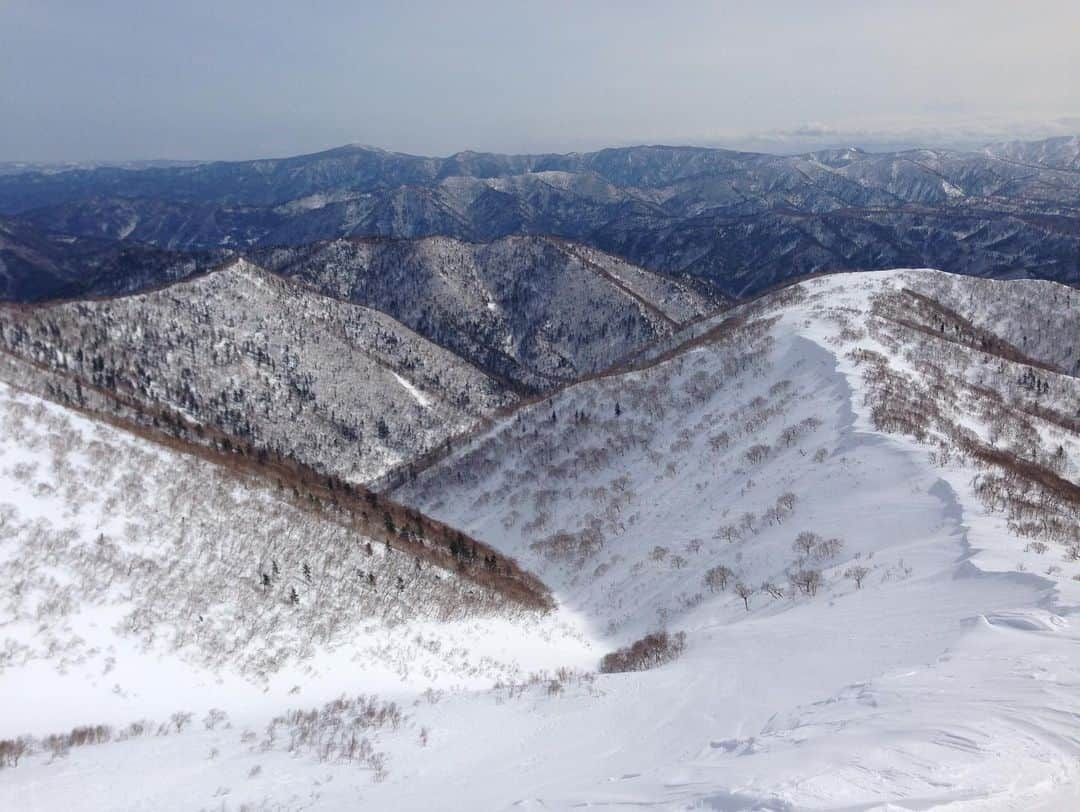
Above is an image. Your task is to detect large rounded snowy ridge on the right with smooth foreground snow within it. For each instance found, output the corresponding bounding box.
[0,271,1080,810]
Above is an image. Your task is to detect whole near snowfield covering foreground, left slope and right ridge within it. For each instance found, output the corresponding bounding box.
[0,271,1080,810]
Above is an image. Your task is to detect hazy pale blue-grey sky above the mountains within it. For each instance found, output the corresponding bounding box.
[0,0,1080,161]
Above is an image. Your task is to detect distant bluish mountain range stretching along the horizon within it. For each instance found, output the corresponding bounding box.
[0,137,1080,297]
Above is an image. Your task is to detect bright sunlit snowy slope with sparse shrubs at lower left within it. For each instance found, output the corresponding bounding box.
[0,377,591,794]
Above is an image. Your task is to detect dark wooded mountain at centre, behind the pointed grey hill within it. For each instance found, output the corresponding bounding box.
[255,236,718,391]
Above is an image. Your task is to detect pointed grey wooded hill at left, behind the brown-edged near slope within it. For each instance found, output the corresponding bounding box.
[0,260,514,482]
